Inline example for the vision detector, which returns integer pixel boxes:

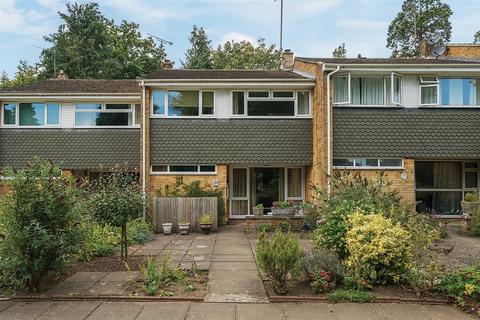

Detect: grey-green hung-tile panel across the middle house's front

[150,119,312,165]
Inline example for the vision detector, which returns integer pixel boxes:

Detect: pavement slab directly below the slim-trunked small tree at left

[85,302,144,320]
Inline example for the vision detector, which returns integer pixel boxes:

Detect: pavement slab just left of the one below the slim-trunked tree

[37,301,101,320]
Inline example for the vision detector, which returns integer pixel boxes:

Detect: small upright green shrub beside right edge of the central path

[257,230,303,294]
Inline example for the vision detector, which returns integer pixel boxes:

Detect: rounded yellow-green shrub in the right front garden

[346,212,412,284]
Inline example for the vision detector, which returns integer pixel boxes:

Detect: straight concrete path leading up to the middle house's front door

[205,224,267,302]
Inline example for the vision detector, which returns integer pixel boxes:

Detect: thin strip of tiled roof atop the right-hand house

[295,57,480,65]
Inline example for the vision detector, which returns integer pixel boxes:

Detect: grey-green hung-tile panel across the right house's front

[333,107,480,159]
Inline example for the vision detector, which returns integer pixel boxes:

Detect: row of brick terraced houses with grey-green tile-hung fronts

[0,46,480,219]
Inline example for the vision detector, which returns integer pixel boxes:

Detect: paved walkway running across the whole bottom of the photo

[0,301,474,320]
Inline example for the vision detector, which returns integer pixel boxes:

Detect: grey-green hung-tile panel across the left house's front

[0,129,140,169]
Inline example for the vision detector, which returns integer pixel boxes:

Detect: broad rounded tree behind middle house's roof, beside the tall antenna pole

[213,38,282,70]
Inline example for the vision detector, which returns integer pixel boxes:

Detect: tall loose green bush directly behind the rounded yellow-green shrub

[310,172,400,259]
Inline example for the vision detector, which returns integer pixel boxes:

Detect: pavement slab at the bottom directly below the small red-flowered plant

[282,303,341,320]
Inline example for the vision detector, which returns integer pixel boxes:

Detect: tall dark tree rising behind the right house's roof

[387,0,452,58]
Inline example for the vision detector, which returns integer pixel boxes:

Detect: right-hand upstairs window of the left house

[75,103,136,127]
